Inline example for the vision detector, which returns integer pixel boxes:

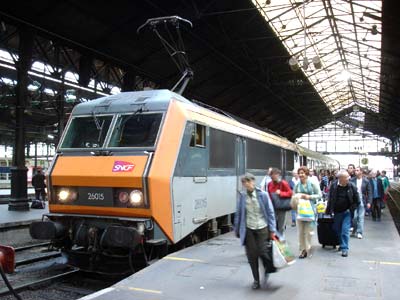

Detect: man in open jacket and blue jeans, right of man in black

[350,167,372,239]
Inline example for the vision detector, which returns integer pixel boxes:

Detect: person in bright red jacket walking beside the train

[268,168,292,239]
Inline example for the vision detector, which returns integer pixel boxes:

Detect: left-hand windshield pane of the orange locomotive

[61,116,113,148]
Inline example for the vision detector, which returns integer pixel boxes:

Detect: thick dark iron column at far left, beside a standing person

[8,28,34,210]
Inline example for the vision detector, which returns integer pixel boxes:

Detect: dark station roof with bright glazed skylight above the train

[0,0,400,140]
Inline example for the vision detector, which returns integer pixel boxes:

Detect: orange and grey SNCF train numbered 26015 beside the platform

[30,90,338,273]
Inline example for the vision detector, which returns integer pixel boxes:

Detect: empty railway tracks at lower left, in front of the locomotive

[0,242,122,300]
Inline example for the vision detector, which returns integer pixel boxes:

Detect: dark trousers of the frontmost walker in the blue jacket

[245,227,276,282]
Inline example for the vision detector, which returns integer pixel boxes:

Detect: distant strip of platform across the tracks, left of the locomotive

[0,202,49,229]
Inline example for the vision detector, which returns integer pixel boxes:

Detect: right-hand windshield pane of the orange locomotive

[108,113,162,147]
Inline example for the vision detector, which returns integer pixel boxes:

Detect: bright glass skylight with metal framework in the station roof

[252,0,382,113]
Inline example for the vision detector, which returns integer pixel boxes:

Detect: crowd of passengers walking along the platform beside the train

[235,164,390,289]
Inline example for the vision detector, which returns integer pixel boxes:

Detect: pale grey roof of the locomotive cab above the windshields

[72,90,192,115]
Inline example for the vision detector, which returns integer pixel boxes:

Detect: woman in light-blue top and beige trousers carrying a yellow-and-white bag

[293,166,322,258]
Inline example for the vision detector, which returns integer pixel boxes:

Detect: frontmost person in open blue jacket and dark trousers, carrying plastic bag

[235,174,276,289]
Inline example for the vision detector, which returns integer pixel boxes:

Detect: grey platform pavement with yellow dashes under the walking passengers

[82,210,400,300]
